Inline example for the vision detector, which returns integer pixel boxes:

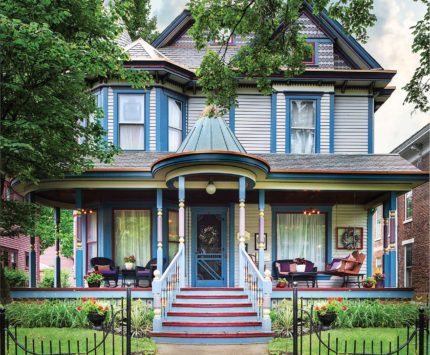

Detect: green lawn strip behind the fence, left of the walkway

[7,328,155,355]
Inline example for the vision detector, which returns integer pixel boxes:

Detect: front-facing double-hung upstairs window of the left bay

[118,94,145,150]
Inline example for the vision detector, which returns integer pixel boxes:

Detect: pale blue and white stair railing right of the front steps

[239,243,272,331]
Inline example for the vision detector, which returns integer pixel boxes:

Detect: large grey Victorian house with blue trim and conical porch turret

[10,3,428,340]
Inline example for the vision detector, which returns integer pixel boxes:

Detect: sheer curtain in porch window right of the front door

[277,213,326,270]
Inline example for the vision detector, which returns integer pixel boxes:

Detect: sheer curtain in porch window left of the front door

[114,210,151,266]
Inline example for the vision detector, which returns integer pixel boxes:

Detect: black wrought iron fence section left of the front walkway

[0,288,154,355]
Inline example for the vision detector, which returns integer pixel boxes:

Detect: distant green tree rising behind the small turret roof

[122,0,159,43]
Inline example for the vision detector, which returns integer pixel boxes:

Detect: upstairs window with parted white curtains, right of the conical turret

[291,100,316,154]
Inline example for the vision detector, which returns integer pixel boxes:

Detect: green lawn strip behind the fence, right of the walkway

[269,328,424,355]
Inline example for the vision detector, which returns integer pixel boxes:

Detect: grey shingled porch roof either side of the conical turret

[94,151,426,175]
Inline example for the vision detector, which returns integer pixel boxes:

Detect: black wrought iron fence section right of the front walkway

[275,285,430,355]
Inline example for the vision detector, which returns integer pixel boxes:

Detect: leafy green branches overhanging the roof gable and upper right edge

[189,0,430,111]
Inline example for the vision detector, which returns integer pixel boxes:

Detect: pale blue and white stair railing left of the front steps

[152,243,185,331]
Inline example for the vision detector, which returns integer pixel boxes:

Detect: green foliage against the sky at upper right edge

[403,0,430,112]
